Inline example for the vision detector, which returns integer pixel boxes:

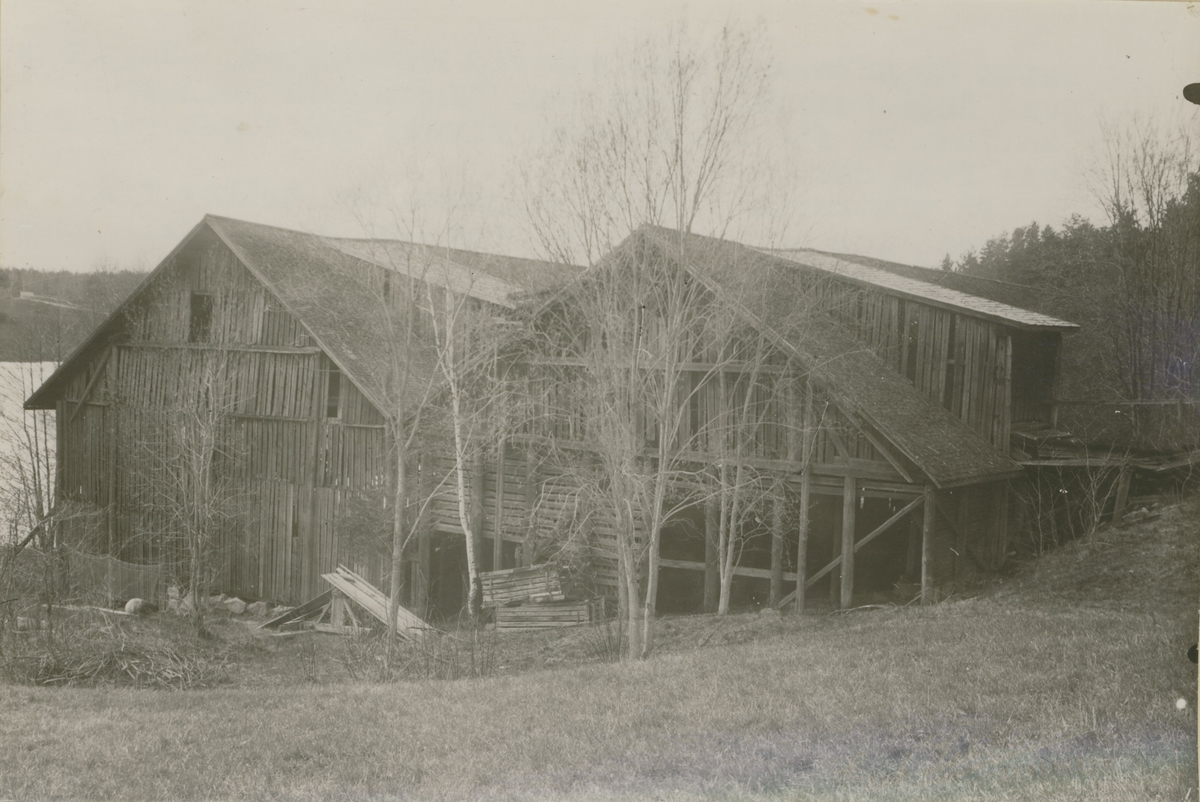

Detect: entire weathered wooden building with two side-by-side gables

[26,216,1074,614]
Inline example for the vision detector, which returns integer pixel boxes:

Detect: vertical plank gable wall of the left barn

[55,235,403,603]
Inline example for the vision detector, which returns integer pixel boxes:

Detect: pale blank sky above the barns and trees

[0,0,1200,270]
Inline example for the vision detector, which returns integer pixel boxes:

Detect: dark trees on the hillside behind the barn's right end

[942,163,1200,451]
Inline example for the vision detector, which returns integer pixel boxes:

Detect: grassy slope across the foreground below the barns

[0,499,1200,800]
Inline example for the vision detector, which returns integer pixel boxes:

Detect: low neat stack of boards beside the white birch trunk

[479,564,604,632]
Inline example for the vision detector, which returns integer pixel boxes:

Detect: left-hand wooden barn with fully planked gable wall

[25,216,569,612]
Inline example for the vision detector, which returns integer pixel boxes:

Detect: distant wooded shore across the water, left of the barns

[0,268,146,361]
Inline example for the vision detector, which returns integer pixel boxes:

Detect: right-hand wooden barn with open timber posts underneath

[506,227,1075,611]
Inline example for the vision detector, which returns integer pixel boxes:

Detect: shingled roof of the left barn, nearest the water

[25,215,572,409]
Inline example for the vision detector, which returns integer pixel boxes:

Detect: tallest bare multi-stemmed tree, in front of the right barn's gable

[522,26,791,657]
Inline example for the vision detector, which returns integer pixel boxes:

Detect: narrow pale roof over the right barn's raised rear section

[767,249,1079,331]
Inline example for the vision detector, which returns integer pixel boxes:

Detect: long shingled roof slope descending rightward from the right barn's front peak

[635,226,1021,487]
